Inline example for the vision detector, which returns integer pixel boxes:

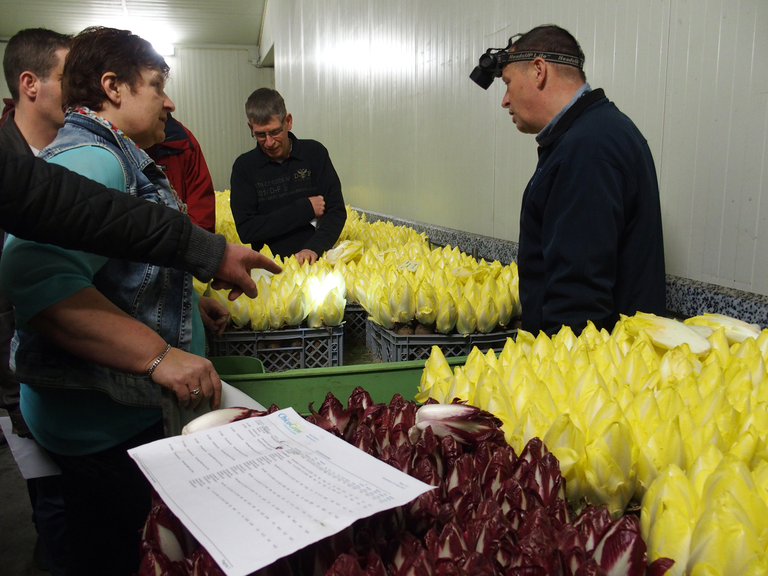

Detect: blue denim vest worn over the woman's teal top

[15,111,193,414]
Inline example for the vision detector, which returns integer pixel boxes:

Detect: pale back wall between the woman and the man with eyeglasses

[168,47,274,190]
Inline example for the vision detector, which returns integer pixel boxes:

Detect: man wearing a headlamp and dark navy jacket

[471,25,666,335]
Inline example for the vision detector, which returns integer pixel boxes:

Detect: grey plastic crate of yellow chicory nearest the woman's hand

[211,326,344,372]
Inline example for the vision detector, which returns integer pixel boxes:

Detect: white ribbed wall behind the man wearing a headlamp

[269,0,768,294]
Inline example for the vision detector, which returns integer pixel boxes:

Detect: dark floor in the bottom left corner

[0,410,50,576]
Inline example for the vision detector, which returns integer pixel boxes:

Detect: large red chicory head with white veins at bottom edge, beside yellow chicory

[592,516,647,576]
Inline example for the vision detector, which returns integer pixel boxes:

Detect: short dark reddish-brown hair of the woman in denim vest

[61,26,170,111]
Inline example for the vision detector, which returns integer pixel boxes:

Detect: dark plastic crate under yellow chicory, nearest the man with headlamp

[366,322,517,362]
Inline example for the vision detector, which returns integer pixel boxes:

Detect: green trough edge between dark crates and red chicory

[210,356,467,414]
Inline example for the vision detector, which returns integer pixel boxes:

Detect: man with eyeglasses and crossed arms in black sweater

[230,88,347,264]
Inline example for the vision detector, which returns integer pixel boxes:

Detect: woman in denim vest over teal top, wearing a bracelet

[0,28,234,576]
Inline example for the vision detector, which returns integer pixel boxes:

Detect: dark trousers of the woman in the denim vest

[45,422,163,576]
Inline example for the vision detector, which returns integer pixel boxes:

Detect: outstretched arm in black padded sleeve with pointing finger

[0,150,279,294]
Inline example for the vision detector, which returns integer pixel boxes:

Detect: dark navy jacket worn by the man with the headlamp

[518,90,666,335]
